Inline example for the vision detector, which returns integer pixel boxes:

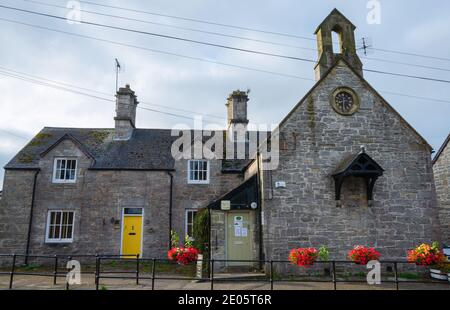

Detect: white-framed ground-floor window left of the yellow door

[45,210,74,242]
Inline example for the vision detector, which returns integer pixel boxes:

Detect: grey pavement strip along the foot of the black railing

[0,274,450,290]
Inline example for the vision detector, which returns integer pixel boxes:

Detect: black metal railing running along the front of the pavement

[0,254,450,290]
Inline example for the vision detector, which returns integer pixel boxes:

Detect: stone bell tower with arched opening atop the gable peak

[314,9,362,80]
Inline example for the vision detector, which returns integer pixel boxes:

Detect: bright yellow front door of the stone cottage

[122,215,142,258]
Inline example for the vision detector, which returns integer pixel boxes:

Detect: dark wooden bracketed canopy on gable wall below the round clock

[333,148,384,201]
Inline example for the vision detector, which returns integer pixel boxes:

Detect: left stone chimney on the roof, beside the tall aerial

[114,84,138,140]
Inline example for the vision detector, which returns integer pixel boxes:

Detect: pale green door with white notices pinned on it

[227,212,254,266]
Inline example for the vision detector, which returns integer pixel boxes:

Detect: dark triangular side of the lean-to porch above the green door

[207,175,259,210]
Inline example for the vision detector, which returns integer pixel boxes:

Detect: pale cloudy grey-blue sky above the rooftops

[0,0,450,188]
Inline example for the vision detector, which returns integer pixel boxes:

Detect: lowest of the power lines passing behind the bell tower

[0,18,450,103]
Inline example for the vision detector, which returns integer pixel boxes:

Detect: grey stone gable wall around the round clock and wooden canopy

[263,62,440,260]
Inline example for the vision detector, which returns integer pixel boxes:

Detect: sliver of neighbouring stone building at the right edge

[433,135,450,247]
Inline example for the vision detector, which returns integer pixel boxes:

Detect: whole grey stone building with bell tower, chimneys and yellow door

[0,10,441,265]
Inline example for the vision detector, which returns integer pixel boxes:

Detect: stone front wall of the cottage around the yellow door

[0,139,242,258]
